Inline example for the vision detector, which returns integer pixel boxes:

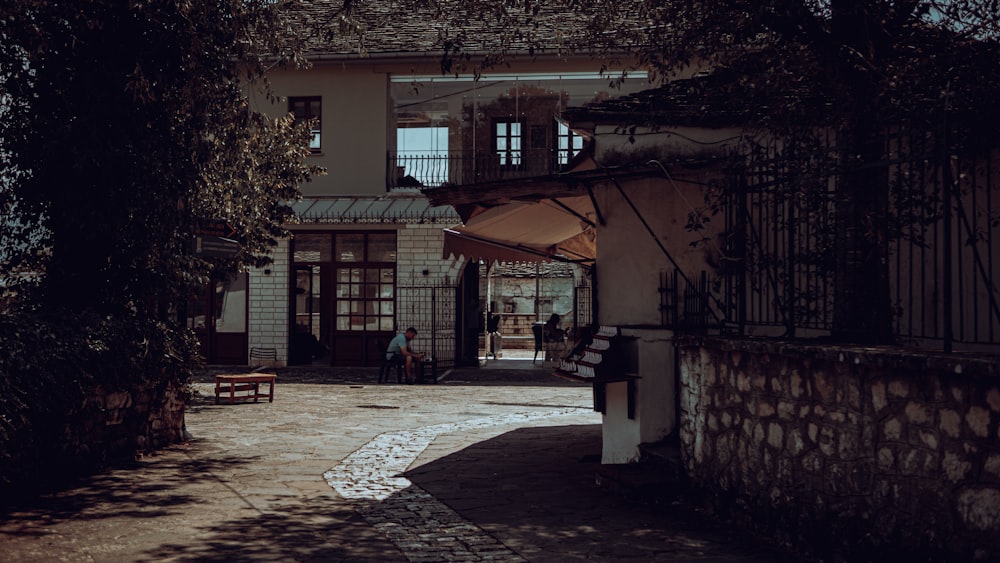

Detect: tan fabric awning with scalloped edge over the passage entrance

[444,196,597,264]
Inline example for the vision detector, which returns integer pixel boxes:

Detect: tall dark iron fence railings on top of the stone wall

[660,131,1000,351]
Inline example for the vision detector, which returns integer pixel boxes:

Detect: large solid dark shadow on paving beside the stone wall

[406,424,795,561]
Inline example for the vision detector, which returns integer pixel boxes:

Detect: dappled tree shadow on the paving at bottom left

[0,448,405,563]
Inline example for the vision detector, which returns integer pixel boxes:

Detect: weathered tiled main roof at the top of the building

[284,0,645,58]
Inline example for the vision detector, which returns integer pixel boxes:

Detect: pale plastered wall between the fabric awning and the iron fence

[597,131,731,463]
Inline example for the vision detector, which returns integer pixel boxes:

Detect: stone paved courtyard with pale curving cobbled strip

[0,362,786,562]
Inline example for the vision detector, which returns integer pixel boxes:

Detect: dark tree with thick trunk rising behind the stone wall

[608,0,1000,342]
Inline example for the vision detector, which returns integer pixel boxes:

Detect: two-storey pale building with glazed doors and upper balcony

[189,2,648,366]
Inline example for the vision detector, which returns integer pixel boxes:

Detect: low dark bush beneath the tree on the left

[0,311,199,496]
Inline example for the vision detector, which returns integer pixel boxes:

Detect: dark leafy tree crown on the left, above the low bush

[0,0,316,316]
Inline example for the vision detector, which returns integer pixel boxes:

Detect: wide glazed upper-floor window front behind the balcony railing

[386,72,655,188]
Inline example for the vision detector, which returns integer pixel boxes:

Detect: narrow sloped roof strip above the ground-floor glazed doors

[292,193,461,225]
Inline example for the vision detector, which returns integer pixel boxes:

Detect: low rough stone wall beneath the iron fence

[679,339,1000,560]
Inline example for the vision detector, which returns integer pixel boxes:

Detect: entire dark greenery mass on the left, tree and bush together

[0,0,318,494]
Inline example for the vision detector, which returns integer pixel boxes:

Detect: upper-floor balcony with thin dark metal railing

[385,148,568,190]
